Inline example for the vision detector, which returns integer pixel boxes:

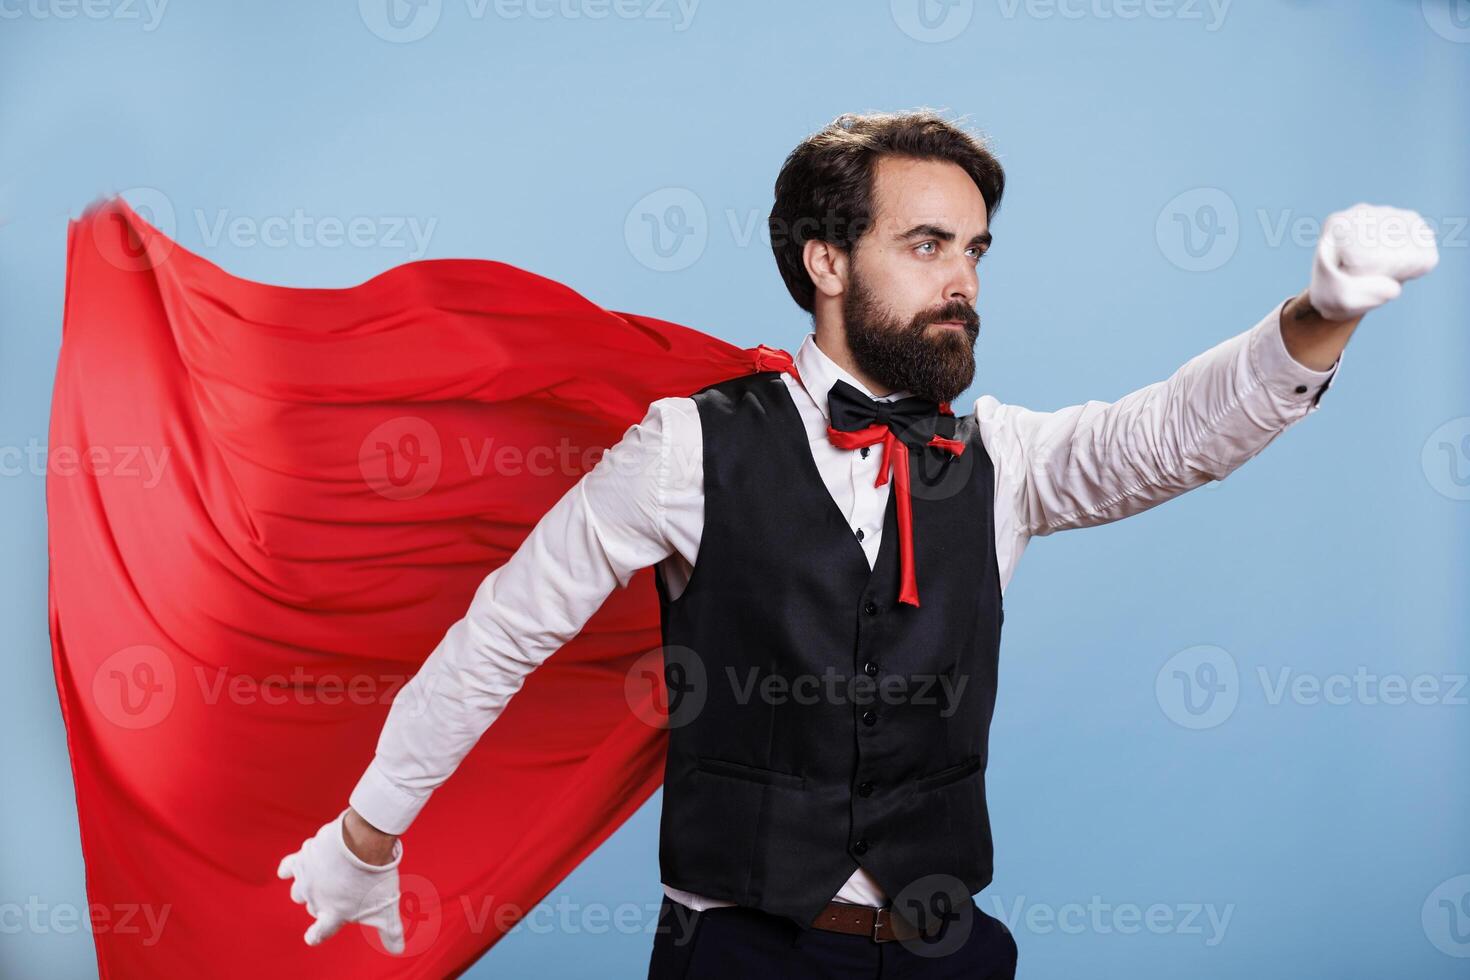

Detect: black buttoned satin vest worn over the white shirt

[656,370,1004,926]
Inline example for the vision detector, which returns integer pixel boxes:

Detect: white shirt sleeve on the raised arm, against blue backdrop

[975,300,1341,586]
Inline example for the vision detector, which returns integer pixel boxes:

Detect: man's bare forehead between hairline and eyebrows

[873,157,989,238]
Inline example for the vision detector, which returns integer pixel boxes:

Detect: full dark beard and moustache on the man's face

[844,265,980,403]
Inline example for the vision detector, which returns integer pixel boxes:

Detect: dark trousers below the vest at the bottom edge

[648,895,1017,980]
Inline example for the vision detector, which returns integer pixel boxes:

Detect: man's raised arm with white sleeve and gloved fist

[975,206,1438,583]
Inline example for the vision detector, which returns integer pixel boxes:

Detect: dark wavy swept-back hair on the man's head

[767,109,1005,313]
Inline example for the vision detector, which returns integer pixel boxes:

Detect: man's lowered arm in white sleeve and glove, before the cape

[276,398,682,952]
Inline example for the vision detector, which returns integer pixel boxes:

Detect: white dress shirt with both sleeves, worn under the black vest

[350,301,1341,908]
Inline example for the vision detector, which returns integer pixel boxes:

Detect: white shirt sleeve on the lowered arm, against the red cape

[348,398,679,835]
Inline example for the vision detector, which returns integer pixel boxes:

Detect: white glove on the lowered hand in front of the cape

[276,808,403,954]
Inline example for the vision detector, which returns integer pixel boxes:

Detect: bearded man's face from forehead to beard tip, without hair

[842,157,991,401]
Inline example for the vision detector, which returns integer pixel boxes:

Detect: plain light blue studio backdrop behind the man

[0,0,1470,980]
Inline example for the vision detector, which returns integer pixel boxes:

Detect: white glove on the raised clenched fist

[1307,204,1439,320]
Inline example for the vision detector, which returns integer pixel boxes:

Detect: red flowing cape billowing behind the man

[46,198,789,979]
